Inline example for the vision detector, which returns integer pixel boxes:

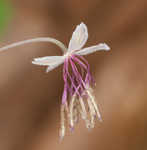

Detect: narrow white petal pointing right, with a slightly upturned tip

[75,43,110,55]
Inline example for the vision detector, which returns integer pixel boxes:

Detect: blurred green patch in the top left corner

[0,0,12,36]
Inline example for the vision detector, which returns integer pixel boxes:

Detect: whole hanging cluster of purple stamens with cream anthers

[59,55,101,138]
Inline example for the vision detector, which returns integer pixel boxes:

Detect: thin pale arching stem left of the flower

[0,37,67,53]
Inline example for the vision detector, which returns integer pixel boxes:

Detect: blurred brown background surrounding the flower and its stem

[0,0,147,150]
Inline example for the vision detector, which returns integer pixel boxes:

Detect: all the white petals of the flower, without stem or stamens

[32,23,110,72]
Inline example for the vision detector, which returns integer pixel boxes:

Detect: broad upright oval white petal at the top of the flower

[68,23,88,51]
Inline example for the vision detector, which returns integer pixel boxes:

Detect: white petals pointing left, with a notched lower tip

[32,56,64,72]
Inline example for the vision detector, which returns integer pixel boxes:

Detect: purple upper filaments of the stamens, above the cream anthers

[62,55,94,104]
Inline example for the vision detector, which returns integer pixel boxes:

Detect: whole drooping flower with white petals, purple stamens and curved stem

[0,23,110,138]
